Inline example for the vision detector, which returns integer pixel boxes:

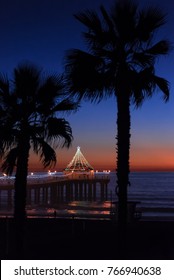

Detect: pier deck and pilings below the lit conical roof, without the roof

[0,174,109,207]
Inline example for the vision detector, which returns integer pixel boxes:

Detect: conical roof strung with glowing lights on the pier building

[65,147,94,172]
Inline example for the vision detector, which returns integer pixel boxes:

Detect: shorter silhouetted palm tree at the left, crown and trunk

[0,63,77,221]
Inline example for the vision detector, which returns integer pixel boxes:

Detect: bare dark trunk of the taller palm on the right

[117,89,130,234]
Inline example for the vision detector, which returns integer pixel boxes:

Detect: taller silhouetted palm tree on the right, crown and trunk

[65,0,171,228]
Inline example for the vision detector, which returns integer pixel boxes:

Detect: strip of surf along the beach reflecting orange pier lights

[0,203,174,221]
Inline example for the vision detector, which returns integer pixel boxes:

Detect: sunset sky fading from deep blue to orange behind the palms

[0,0,174,171]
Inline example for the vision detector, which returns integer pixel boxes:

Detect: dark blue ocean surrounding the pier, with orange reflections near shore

[0,172,174,220]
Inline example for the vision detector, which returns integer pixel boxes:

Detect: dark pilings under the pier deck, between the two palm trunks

[27,178,109,204]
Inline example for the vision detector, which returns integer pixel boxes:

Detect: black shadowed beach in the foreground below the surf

[0,218,174,260]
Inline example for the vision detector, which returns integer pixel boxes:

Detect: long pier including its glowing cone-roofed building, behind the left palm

[0,147,110,208]
